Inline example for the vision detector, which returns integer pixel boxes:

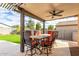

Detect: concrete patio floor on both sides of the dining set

[0,40,77,56]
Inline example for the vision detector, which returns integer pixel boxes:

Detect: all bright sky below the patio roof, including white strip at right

[0,7,77,27]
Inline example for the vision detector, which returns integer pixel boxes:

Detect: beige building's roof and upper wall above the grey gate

[56,20,78,30]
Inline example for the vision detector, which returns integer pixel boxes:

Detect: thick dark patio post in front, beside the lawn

[20,9,24,52]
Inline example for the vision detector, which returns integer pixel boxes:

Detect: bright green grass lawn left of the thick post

[0,34,20,43]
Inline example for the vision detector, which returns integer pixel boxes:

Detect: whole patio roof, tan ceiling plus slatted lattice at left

[0,3,79,21]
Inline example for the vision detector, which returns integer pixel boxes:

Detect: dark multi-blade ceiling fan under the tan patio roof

[47,3,64,18]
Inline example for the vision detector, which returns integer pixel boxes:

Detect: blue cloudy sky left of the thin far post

[0,7,40,26]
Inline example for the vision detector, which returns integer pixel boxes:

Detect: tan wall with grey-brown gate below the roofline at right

[56,26,78,41]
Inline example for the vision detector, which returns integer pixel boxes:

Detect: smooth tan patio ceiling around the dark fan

[20,3,79,20]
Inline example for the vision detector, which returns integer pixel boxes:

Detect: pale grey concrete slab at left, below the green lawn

[0,40,20,56]
